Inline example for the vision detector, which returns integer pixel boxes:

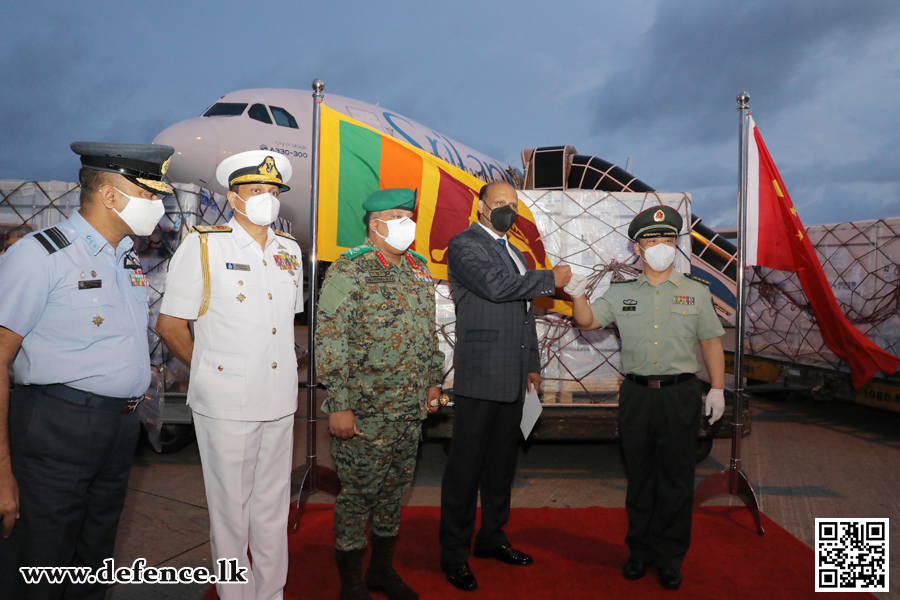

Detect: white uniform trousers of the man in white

[194,413,294,600]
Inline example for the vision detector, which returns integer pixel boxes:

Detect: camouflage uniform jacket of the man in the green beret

[316,246,444,421]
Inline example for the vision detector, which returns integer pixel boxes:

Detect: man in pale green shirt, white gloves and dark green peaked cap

[566,206,725,589]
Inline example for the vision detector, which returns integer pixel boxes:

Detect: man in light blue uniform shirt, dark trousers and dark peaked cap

[0,142,174,600]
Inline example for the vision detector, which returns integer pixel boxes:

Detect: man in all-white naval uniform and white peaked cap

[156,150,303,600]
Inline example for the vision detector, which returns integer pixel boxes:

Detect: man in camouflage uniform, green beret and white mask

[316,189,444,600]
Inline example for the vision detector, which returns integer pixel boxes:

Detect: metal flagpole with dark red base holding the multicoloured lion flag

[288,79,341,532]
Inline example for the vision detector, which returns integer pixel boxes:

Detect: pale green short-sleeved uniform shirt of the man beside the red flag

[591,271,725,376]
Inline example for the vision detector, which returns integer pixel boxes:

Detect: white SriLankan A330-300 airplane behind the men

[153,88,522,248]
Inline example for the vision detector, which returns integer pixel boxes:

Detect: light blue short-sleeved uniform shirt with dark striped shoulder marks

[0,212,150,398]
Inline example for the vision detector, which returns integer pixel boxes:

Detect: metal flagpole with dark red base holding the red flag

[694,92,765,535]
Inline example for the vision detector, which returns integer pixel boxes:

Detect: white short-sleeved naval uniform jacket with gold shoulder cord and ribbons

[160,219,303,421]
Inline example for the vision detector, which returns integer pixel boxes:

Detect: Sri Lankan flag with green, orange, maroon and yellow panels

[317,105,551,279]
